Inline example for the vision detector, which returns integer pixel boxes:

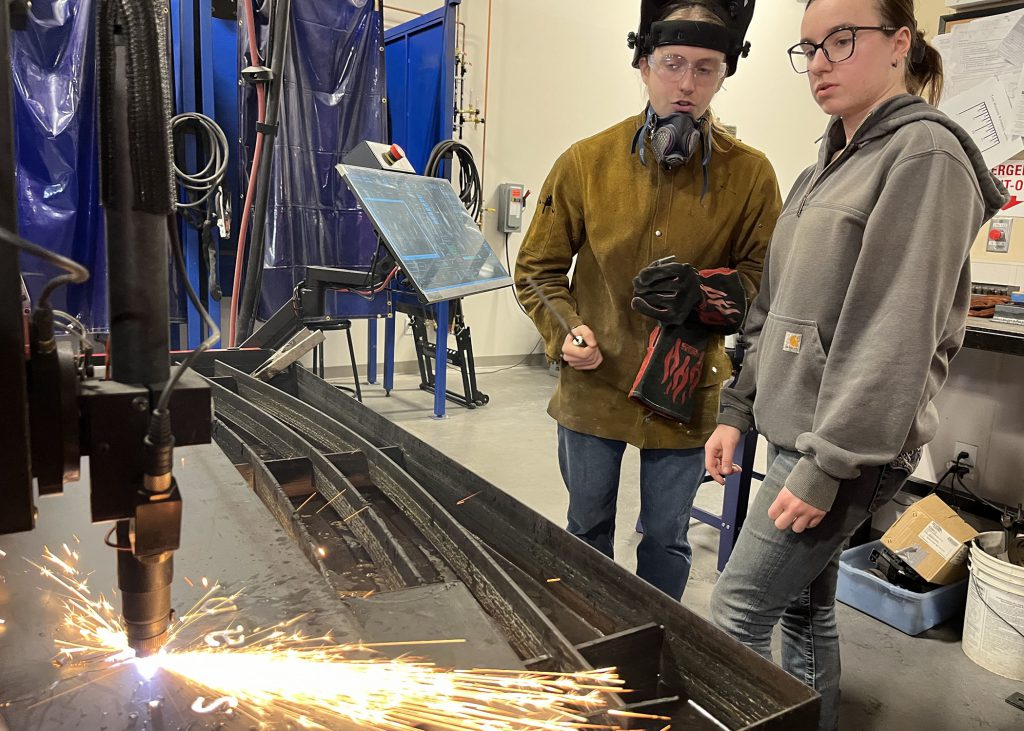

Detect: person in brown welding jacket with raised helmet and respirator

[515,1,781,599]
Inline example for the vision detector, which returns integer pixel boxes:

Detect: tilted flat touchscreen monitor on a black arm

[338,165,512,303]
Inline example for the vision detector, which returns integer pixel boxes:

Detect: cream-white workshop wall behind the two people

[321,0,1024,503]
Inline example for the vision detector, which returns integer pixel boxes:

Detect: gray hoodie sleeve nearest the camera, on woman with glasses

[786,148,984,510]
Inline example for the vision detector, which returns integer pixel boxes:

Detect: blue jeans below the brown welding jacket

[558,426,705,600]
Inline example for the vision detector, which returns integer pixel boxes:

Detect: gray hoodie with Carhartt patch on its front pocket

[719,94,1008,510]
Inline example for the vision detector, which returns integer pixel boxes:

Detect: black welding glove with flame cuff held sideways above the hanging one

[630,259,746,335]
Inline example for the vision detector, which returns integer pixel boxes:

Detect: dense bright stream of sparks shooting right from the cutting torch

[162,637,617,731]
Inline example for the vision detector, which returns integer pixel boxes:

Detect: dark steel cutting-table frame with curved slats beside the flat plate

[203,363,819,731]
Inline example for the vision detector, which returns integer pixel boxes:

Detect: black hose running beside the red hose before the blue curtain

[237,0,292,342]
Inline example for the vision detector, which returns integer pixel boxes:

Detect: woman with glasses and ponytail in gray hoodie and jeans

[707,0,1007,731]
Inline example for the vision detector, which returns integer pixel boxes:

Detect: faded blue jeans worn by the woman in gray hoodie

[711,447,908,731]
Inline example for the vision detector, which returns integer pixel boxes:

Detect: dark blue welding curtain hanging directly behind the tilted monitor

[239,0,387,319]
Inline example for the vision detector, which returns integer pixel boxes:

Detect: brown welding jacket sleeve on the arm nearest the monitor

[515,147,586,360]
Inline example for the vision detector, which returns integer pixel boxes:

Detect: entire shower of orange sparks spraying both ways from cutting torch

[30,546,634,731]
